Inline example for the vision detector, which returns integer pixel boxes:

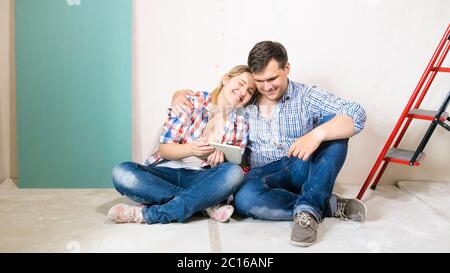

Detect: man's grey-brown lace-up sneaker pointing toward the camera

[291,211,319,246]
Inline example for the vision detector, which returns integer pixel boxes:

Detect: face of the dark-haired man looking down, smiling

[253,59,290,102]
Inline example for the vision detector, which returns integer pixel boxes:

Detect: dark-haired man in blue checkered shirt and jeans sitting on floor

[171,41,366,246]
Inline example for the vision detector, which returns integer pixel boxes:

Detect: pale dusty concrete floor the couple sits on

[0,177,450,252]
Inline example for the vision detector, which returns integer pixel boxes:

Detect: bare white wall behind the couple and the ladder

[133,0,450,184]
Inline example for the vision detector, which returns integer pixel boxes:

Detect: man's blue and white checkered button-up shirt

[245,78,366,167]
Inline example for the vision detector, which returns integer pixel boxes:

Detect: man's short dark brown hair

[247,41,288,73]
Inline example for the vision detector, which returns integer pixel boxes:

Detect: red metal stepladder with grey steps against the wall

[356,24,450,200]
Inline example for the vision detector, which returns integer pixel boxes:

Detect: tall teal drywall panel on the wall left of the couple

[15,0,132,188]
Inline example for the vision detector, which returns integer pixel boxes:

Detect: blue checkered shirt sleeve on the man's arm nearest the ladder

[305,86,367,135]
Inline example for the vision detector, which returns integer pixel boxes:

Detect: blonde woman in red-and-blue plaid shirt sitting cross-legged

[108,65,256,224]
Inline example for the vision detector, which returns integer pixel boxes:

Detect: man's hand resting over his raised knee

[288,128,325,161]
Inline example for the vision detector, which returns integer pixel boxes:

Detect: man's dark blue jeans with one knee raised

[234,116,348,221]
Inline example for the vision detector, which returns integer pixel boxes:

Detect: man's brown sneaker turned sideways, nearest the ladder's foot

[333,193,367,221]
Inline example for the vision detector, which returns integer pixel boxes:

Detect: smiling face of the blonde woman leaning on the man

[221,72,256,107]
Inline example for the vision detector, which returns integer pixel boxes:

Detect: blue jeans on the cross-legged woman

[112,162,244,224]
